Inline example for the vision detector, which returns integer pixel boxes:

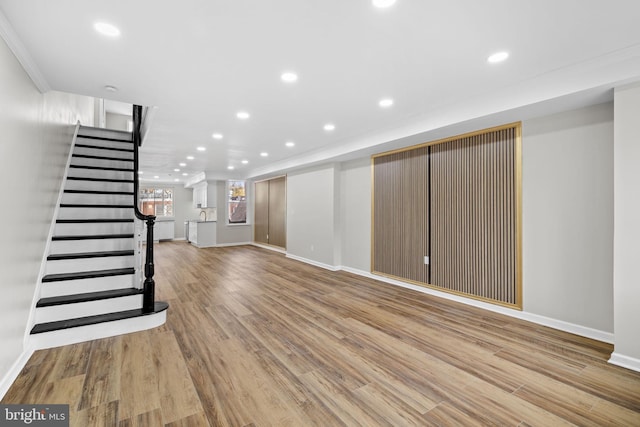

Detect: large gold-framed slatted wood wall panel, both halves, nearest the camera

[372,123,522,308]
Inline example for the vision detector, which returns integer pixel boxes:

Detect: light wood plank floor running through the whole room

[2,242,640,426]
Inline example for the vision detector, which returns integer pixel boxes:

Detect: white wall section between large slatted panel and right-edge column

[522,103,613,332]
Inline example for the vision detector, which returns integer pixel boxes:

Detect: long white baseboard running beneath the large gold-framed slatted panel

[342,267,614,344]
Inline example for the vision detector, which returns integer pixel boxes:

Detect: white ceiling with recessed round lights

[0,0,640,184]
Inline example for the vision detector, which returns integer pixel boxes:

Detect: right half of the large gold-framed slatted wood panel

[431,128,518,305]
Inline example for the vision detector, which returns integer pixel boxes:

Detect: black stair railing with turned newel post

[133,105,156,313]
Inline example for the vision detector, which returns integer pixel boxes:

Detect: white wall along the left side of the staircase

[0,39,94,389]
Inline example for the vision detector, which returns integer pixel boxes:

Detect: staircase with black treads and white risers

[31,127,168,348]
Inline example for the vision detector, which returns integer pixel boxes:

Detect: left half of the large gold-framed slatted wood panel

[372,147,429,283]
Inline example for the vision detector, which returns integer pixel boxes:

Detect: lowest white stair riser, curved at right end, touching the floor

[29,310,167,349]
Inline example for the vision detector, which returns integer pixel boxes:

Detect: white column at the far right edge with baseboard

[609,82,640,371]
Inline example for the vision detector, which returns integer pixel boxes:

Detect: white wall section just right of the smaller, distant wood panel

[287,164,340,267]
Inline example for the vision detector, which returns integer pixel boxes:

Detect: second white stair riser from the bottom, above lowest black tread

[35,295,142,323]
